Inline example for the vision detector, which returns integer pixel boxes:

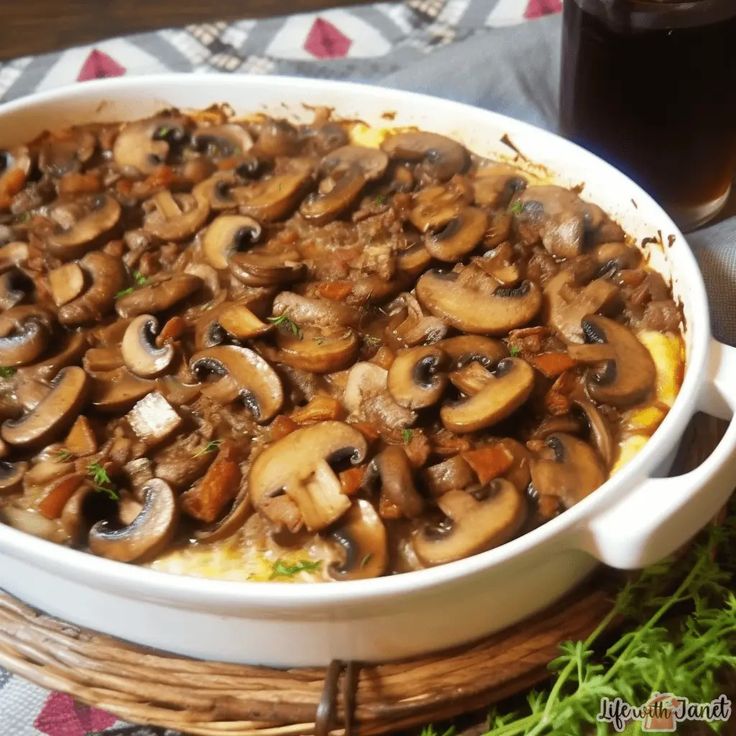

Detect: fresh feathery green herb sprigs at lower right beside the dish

[423,509,736,736]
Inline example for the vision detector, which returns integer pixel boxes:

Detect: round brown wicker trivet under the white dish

[0,579,610,736]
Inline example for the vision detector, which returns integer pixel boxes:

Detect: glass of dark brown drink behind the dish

[560,0,736,229]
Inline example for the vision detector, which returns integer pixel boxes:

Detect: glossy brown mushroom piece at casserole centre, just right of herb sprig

[276,329,360,373]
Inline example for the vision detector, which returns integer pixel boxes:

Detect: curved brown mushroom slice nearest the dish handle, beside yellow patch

[582,315,657,408]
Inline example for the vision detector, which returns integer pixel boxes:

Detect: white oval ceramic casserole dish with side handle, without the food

[0,75,736,667]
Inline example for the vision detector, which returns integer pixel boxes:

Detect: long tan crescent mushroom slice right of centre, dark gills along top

[416,270,542,335]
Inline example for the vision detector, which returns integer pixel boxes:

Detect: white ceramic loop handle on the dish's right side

[580,340,736,570]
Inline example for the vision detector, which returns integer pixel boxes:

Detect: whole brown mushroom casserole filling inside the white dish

[0,108,684,581]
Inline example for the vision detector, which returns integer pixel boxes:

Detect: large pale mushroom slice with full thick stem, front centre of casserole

[248,421,367,531]
